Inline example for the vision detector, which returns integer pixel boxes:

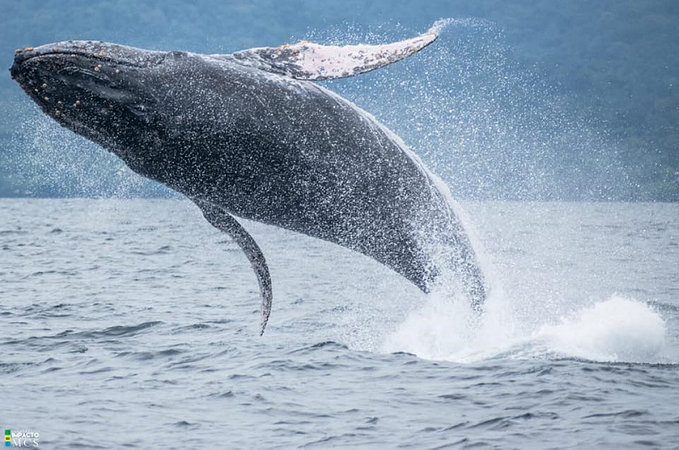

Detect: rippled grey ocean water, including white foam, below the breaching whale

[0,199,679,449]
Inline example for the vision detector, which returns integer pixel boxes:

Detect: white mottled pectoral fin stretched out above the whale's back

[228,31,438,80]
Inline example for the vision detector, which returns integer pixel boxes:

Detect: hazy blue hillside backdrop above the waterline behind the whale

[0,0,679,201]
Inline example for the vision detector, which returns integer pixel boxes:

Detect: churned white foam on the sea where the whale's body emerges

[382,289,666,363]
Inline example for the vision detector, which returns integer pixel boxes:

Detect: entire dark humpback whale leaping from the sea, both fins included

[10,26,487,333]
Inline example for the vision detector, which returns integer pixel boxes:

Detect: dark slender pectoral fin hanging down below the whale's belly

[194,200,273,336]
